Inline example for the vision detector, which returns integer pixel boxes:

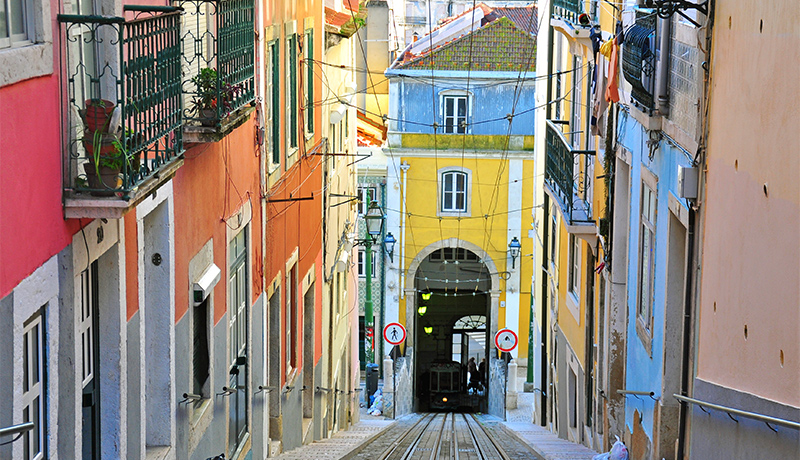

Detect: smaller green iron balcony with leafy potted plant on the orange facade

[179,0,255,144]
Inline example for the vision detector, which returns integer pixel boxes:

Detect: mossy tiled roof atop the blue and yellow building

[398,17,536,71]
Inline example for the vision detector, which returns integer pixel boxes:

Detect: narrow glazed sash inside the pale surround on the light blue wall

[637,182,656,330]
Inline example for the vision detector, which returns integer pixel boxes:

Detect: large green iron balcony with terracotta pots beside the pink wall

[58,6,183,218]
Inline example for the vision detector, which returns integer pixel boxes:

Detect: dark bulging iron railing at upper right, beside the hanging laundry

[622,10,656,110]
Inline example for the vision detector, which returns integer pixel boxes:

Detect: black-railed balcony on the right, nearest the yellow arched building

[544,120,595,233]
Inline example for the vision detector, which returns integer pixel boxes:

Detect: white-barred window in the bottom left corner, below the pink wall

[22,314,45,460]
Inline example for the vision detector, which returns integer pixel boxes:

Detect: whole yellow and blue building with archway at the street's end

[384,7,536,414]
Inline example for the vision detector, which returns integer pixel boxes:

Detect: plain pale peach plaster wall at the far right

[697,0,800,408]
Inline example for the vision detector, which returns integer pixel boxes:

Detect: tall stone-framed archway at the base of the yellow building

[405,238,499,412]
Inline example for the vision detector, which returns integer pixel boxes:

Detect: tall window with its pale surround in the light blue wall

[636,168,658,341]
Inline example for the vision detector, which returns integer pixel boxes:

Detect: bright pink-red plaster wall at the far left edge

[0,52,79,296]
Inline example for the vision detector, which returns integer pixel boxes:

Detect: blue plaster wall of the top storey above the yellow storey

[387,75,536,135]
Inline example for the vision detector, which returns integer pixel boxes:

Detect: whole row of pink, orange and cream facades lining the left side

[0,0,358,459]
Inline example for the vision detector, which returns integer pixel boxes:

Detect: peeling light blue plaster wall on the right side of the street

[618,109,691,440]
